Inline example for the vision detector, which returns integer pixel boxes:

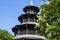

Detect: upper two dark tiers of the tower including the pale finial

[18,1,39,23]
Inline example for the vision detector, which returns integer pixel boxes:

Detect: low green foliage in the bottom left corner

[0,29,13,40]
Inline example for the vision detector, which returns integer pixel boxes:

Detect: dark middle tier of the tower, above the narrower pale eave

[18,14,38,23]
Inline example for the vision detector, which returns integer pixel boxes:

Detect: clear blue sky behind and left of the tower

[0,0,47,33]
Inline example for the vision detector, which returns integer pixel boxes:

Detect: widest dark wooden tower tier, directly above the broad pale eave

[12,24,39,36]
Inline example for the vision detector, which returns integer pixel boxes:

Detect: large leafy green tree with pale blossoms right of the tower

[36,0,60,40]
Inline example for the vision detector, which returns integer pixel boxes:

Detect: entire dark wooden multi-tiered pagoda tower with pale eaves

[12,1,46,40]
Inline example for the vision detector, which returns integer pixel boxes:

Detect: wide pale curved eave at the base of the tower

[13,35,46,40]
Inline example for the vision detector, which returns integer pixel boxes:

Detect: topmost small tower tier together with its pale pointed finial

[23,1,39,14]
